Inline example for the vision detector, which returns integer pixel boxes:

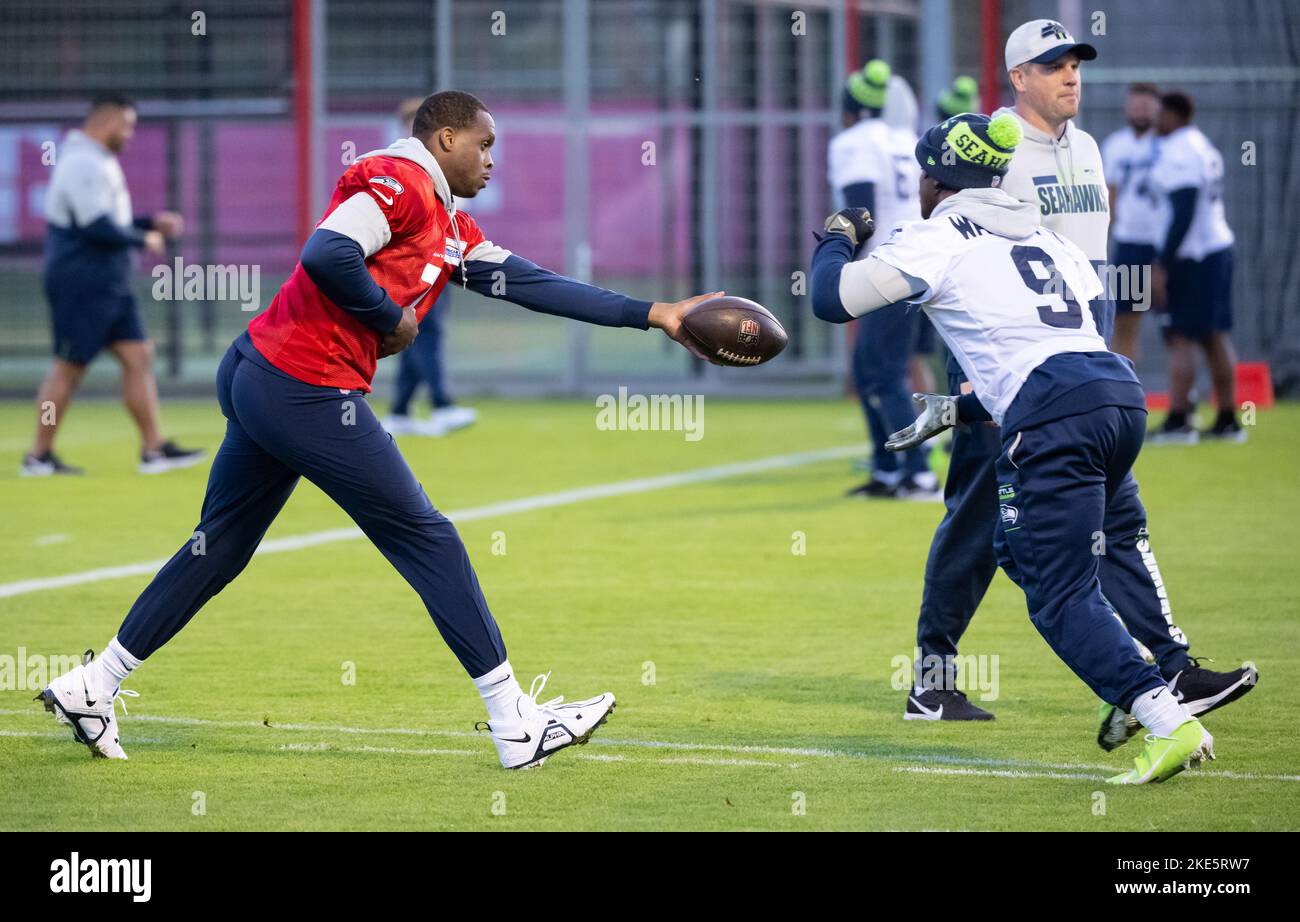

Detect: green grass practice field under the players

[0,401,1300,830]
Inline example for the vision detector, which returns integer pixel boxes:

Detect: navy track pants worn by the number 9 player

[995,407,1165,710]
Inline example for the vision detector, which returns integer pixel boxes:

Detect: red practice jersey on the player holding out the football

[248,151,484,391]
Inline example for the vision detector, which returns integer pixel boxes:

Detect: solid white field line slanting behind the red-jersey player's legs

[0,443,866,598]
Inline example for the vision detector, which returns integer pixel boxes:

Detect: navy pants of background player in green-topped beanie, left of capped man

[853,302,930,476]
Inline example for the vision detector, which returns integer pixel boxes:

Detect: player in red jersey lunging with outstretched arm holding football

[38,91,722,769]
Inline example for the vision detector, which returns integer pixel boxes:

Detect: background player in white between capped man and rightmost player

[1101,83,1167,362]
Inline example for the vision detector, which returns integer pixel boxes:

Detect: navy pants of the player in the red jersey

[117,337,506,678]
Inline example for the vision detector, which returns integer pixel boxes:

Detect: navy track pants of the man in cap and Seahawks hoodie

[917,364,1188,688]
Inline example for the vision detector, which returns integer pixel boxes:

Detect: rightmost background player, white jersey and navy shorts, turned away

[1152,92,1245,442]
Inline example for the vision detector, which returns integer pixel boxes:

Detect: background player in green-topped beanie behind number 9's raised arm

[827,60,939,499]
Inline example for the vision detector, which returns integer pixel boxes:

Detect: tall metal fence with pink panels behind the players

[0,0,1300,395]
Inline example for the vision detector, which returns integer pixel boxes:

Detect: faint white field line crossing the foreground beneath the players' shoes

[0,709,1300,782]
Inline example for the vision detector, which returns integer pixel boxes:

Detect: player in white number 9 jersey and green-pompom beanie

[811,114,1214,784]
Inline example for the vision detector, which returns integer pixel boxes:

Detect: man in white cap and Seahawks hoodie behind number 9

[893,20,1257,750]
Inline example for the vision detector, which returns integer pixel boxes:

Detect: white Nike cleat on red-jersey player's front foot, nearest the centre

[475,672,614,769]
